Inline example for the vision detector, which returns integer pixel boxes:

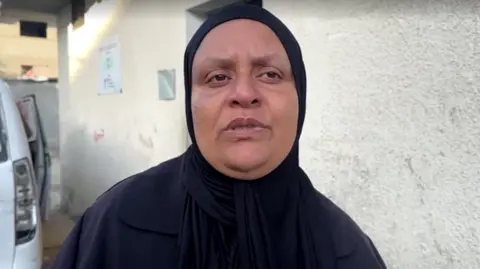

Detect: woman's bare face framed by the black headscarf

[191,19,298,180]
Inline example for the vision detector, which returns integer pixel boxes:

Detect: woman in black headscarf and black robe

[49,6,386,269]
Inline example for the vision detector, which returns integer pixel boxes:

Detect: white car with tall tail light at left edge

[0,80,43,269]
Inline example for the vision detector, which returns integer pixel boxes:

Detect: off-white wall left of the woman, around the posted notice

[59,0,202,215]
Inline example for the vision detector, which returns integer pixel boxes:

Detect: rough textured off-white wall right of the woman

[266,0,480,269]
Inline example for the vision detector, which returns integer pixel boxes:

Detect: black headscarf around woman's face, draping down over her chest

[178,5,333,269]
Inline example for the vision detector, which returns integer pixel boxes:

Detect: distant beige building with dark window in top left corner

[0,10,58,78]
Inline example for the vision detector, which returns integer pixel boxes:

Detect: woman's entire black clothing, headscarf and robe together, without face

[49,6,386,269]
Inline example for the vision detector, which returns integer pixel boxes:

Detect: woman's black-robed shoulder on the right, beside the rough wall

[312,192,386,268]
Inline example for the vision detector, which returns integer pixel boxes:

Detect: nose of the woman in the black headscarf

[228,77,261,108]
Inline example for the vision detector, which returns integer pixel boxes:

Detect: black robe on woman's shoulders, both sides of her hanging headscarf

[52,155,387,269]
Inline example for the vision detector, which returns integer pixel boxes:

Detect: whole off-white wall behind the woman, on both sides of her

[59,0,480,269]
